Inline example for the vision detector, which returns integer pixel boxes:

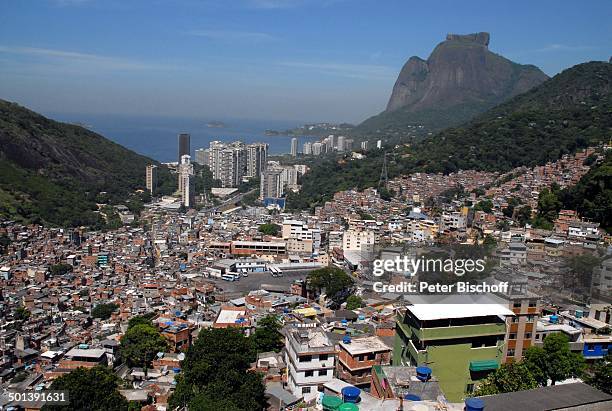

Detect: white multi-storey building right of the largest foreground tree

[285,328,336,401]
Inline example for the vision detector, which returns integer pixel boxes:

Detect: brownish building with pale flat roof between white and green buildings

[336,336,391,386]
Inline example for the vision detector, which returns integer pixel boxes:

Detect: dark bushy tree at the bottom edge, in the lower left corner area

[42,366,128,411]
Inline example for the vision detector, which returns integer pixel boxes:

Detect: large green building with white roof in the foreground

[393,304,514,401]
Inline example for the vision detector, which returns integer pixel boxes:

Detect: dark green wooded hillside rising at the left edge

[0,100,165,226]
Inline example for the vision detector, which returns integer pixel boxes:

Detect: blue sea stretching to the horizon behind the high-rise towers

[50,114,319,162]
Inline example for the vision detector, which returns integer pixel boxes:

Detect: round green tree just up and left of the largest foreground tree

[120,323,168,368]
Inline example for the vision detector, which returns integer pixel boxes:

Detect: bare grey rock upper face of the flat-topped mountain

[387,33,548,111]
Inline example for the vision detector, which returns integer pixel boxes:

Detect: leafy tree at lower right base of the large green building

[474,363,538,397]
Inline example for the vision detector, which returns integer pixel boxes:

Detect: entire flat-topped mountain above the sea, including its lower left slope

[356,33,548,135]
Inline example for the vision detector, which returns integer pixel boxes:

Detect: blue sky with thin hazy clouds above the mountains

[0,0,612,122]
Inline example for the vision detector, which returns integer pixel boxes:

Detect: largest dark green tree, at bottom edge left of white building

[169,328,267,411]
